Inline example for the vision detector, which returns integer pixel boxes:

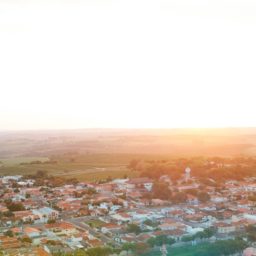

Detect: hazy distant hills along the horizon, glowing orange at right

[0,128,256,159]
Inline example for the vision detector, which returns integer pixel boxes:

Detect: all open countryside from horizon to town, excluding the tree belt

[0,128,256,181]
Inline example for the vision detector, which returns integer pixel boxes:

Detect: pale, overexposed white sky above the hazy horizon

[0,0,256,130]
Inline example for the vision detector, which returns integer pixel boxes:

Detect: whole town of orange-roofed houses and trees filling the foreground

[0,157,256,256]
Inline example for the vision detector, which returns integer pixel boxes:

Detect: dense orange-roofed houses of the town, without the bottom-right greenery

[0,169,256,255]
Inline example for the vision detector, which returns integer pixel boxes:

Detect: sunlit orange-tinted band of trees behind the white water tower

[128,157,256,182]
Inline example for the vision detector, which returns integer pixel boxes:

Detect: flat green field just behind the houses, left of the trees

[0,154,138,181]
